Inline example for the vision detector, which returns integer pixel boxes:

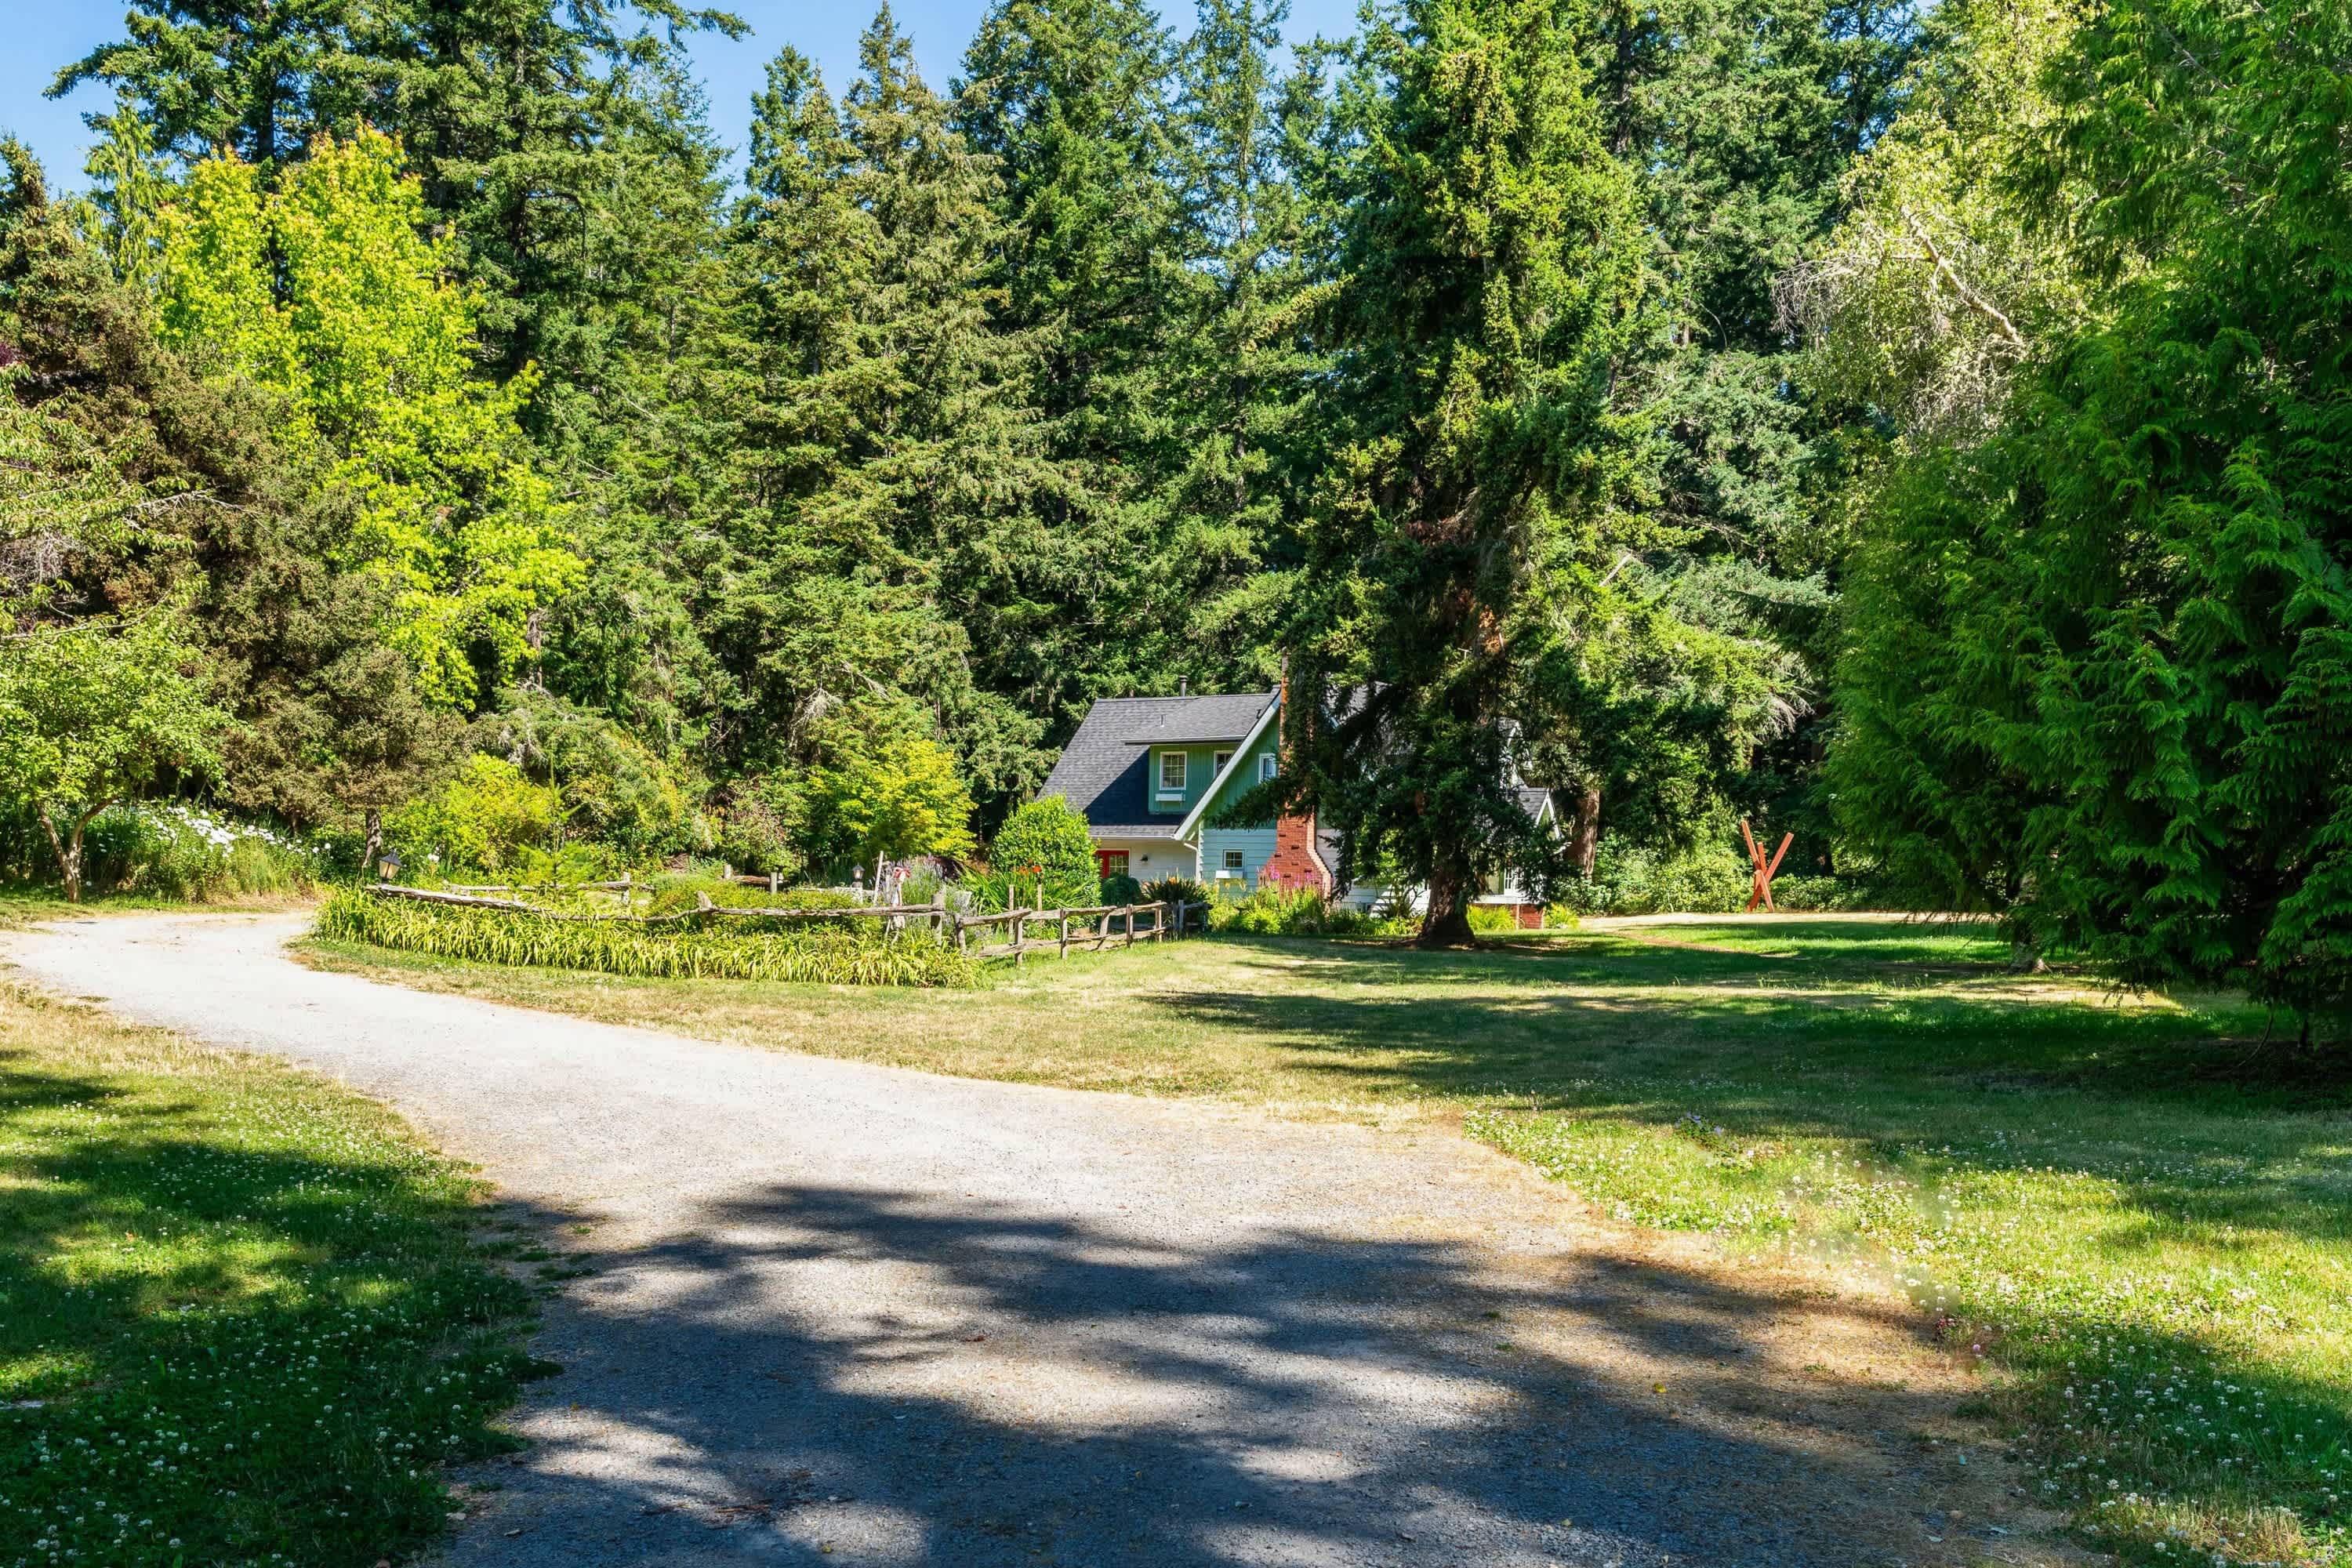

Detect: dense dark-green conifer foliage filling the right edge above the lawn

[1837,0,2352,1011]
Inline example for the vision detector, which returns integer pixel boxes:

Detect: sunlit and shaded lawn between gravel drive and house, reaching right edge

[315,916,2352,1563]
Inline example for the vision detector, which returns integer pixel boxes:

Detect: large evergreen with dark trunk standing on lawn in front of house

[1282,0,1651,942]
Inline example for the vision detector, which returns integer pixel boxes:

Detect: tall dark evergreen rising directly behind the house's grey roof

[955,0,1192,710]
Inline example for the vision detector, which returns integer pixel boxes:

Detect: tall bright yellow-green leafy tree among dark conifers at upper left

[162,129,581,708]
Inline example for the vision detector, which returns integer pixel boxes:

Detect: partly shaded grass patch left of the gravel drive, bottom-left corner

[0,985,534,1568]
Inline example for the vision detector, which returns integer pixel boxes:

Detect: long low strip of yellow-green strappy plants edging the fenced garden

[318,888,974,985]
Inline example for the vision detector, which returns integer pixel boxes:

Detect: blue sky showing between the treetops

[0,0,1355,188]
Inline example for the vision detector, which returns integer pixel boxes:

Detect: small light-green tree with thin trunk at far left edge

[0,609,228,902]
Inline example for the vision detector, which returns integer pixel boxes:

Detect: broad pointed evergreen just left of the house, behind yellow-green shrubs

[703,21,1073,794]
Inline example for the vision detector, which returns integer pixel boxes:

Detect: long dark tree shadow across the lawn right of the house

[1145,926,2352,1243]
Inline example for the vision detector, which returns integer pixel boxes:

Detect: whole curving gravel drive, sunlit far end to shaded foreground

[7,916,2042,1568]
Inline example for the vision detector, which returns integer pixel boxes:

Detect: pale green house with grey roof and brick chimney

[1037,689,1557,926]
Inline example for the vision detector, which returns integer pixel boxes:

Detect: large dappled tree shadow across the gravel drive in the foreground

[433,1187,1992,1568]
